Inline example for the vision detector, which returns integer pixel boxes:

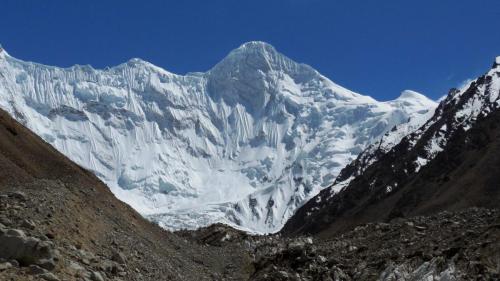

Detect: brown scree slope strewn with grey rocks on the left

[0,107,252,281]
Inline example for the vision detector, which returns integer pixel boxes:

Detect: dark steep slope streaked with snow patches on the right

[283,58,500,237]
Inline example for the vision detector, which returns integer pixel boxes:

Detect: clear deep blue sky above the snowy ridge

[0,0,500,100]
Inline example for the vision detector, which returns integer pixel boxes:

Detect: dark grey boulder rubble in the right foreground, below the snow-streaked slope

[252,208,500,281]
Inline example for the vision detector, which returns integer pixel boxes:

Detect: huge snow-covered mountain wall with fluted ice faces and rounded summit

[0,42,436,230]
